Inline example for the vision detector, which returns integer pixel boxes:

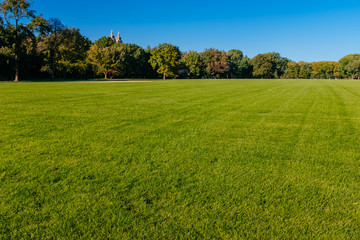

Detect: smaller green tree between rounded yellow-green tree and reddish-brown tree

[180,51,203,78]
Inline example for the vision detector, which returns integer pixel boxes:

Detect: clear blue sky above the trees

[33,0,360,61]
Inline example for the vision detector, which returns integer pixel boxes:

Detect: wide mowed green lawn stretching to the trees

[0,80,360,239]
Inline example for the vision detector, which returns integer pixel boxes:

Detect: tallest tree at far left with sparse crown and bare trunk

[0,0,36,82]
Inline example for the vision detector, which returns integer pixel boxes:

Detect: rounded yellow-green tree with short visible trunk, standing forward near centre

[149,43,181,79]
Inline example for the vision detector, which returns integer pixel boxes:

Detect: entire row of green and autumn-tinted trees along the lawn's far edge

[0,0,360,81]
